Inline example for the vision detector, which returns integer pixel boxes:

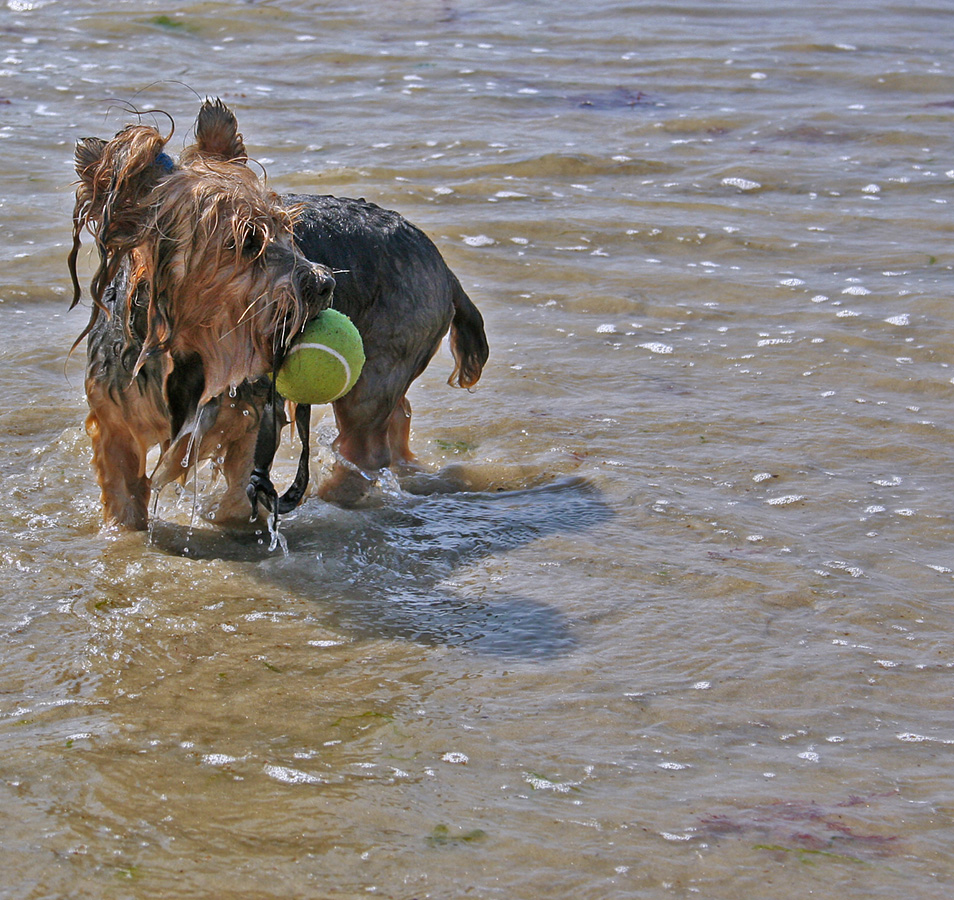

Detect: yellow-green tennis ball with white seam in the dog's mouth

[275,309,364,404]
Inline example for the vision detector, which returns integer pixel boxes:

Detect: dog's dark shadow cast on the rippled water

[152,478,613,659]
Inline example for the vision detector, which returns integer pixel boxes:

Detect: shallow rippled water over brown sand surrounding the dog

[0,0,954,900]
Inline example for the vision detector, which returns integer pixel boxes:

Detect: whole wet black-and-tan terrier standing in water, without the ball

[69,100,488,529]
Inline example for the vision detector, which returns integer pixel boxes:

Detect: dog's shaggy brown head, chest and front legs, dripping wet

[69,102,334,528]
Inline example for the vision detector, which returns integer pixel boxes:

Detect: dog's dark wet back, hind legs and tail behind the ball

[283,194,489,503]
